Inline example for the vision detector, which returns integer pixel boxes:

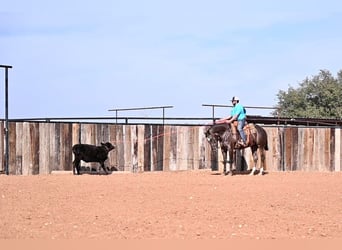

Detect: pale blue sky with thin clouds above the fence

[0,0,342,118]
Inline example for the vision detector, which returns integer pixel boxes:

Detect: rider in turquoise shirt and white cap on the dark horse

[216,96,248,147]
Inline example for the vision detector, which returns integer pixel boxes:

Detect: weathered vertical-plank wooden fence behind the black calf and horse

[0,122,342,175]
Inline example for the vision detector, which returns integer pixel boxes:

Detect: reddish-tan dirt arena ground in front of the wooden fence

[0,171,342,239]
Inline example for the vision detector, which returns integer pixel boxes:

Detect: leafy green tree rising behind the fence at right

[272,70,342,119]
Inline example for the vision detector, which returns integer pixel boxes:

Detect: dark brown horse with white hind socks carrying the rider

[205,123,268,175]
